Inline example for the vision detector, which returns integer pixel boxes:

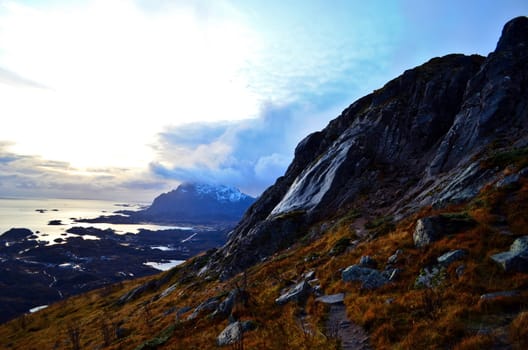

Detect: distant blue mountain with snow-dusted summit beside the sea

[136,183,255,223]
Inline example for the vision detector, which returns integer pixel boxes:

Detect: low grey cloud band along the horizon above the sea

[0,142,171,201]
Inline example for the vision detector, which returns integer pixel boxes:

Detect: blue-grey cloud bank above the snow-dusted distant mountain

[150,103,336,195]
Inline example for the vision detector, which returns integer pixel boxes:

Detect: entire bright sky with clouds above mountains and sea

[0,0,528,202]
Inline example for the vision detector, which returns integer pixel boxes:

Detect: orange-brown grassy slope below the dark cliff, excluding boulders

[0,171,528,350]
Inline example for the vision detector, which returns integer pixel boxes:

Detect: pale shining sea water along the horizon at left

[0,198,190,242]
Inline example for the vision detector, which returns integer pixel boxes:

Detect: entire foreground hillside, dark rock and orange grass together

[0,17,528,349]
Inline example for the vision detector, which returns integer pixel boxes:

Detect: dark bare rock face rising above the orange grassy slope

[208,17,528,278]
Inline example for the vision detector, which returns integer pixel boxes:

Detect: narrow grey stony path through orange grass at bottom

[326,303,371,350]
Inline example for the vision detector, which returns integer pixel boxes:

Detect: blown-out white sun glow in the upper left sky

[0,0,259,167]
